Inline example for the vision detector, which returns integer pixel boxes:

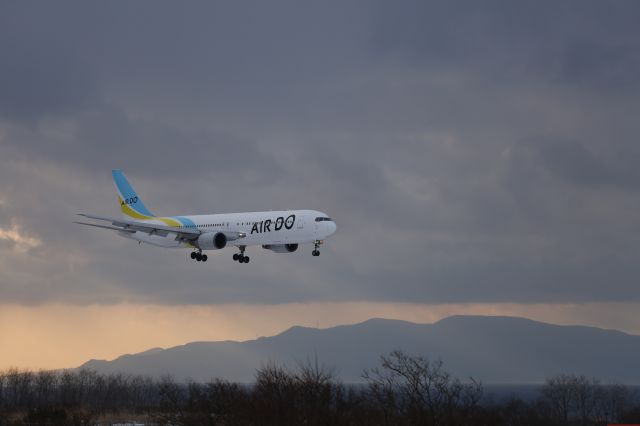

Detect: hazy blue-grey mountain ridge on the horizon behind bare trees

[81,316,640,384]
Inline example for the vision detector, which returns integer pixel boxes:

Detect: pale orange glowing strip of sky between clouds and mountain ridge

[0,302,640,369]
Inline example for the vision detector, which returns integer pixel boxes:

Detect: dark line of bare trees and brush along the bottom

[0,351,640,426]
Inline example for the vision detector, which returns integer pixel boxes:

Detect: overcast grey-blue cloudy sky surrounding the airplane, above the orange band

[0,0,640,368]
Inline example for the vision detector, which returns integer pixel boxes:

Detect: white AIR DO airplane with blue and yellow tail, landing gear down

[74,169,336,263]
